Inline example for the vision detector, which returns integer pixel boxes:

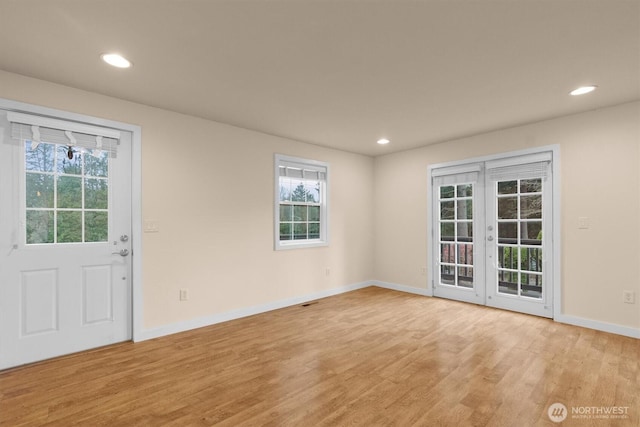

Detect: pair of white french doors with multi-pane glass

[431,152,553,317]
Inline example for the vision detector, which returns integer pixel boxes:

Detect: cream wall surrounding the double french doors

[374,102,640,330]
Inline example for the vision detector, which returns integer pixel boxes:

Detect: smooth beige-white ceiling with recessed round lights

[0,0,640,156]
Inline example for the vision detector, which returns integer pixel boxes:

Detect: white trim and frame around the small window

[273,154,330,251]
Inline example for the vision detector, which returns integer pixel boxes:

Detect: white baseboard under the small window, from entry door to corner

[133,281,372,342]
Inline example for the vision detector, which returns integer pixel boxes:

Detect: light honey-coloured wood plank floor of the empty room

[0,288,640,427]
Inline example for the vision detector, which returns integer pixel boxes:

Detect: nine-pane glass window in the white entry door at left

[24,141,109,245]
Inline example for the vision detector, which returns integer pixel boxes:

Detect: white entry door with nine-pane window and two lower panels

[0,110,131,369]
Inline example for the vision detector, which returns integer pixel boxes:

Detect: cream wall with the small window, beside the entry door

[0,71,373,329]
